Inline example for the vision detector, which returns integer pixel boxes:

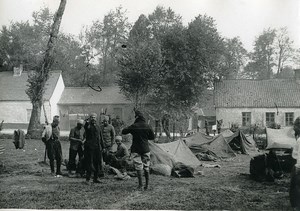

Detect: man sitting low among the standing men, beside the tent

[109,136,129,173]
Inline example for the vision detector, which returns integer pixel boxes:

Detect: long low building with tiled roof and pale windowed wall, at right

[214,69,300,128]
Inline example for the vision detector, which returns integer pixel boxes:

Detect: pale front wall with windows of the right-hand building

[216,108,300,128]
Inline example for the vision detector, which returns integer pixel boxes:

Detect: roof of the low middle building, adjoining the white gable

[58,87,132,105]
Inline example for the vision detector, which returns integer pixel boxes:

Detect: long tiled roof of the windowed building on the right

[214,79,300,108]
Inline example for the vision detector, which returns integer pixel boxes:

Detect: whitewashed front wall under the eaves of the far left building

[0,101,50,129]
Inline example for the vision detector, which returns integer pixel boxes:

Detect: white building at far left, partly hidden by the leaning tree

[0,68,65,129]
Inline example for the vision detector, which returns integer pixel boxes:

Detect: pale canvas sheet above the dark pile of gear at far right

[266,127,296,149]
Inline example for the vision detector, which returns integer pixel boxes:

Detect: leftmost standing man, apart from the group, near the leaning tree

[42,115,62,177]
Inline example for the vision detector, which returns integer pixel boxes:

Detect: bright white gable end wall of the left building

[47,74,65,122]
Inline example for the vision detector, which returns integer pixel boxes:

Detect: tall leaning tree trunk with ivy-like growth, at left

[26,0,67,137]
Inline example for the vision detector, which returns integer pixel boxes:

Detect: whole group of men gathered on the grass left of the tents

[42,110,154,189]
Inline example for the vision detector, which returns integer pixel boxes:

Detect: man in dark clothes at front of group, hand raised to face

[84,113,103,183]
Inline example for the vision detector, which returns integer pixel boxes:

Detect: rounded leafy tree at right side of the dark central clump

[187,15,224,82]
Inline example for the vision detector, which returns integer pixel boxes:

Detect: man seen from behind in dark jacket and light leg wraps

[122,110,155,190]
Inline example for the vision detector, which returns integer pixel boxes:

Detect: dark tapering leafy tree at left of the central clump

[118,15,162,107]
